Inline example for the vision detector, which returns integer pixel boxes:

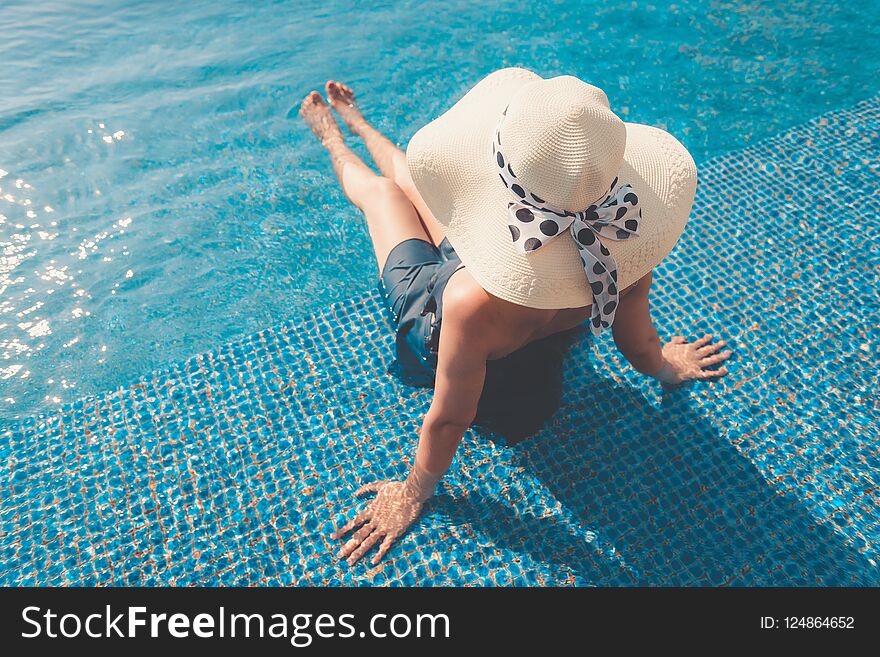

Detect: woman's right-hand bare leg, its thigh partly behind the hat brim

[326,80,443,245]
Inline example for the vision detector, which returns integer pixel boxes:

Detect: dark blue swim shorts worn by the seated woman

[378,237,464,388]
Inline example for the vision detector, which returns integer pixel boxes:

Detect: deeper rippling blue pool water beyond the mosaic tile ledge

[0,0,880,422]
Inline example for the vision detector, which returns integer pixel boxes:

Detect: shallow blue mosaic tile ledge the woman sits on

[0,97,880,585]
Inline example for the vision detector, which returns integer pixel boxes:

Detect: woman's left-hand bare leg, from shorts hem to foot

[300,91,431,274]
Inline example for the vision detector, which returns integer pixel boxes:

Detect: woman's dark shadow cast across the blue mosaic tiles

[458,356,877,586]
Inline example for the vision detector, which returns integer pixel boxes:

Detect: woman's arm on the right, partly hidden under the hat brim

[611,272,731,384]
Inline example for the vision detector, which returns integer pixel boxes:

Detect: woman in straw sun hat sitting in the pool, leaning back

[301,68,730,564]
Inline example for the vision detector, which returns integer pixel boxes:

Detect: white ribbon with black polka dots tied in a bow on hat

[492,116,642,335]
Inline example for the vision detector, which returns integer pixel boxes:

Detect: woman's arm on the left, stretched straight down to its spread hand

[332,290,489,564]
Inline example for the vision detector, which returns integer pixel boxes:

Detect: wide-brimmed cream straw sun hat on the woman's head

[406,68,697,326]
